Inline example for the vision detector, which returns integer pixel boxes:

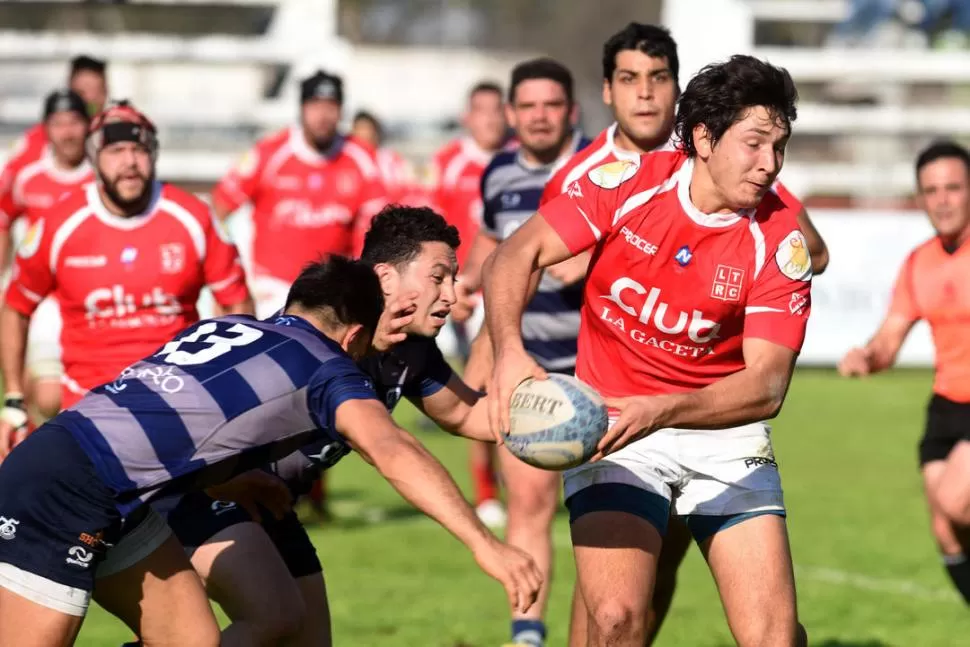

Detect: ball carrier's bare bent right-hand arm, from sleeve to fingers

[592,338,796,460]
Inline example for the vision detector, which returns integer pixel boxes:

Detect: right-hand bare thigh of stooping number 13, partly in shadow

[94,535,219,647]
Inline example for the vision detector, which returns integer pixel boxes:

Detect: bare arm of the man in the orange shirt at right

[838,254,921,377]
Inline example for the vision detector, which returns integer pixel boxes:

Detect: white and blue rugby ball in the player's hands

[505,373,608,471]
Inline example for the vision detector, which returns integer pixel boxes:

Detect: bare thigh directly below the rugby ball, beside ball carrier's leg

[498,447,561,525]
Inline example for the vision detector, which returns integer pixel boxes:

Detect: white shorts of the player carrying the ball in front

[563,420,785,516]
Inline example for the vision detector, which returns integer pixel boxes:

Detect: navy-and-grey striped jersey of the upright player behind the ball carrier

[482,133,590,373]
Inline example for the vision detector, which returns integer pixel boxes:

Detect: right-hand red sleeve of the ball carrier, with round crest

[744,229,812,353]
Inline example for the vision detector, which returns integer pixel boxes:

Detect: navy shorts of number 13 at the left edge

[0,424,123,591]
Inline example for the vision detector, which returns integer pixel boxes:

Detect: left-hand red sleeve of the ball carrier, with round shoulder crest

[539,161,650,254]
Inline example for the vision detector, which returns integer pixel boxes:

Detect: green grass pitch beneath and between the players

[73,370,970,647]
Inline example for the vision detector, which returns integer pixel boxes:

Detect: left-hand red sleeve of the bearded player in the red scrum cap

[6,216,55,317]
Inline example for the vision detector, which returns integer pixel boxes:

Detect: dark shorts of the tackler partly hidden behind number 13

[162,492,323,577]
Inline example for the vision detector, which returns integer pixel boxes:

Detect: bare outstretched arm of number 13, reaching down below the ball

[336,399,542,612]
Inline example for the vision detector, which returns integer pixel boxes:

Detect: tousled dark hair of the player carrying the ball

[675,55,798,157]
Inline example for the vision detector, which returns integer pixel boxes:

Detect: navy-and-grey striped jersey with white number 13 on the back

[52,316,377,514]
